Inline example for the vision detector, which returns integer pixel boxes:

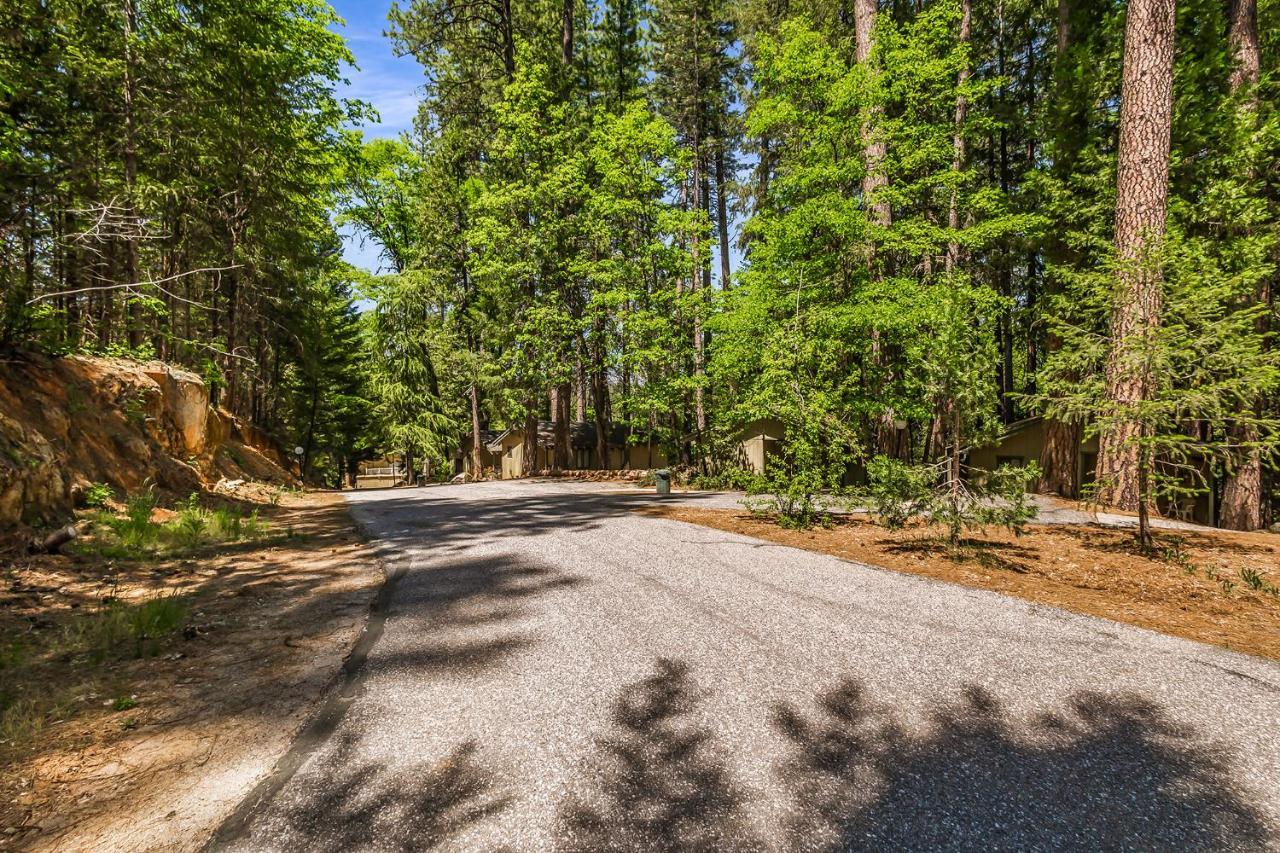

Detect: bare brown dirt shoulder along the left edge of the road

[0,494,383,850]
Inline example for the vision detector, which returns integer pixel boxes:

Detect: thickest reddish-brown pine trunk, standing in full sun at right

[1098,0,1175,512]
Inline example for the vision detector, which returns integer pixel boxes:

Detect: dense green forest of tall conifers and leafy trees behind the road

[0,0,1280,529]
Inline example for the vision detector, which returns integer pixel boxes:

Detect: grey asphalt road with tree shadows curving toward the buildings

[214,482,1280,850]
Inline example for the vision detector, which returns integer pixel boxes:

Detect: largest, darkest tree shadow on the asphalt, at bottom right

[774,680,1268,850]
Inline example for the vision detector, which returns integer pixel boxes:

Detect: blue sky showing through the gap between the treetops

[330,0,422,273]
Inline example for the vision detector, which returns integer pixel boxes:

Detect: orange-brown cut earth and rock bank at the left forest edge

[0,355,292,528]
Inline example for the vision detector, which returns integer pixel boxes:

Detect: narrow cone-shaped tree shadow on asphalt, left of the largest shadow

[561,660,762,853]
